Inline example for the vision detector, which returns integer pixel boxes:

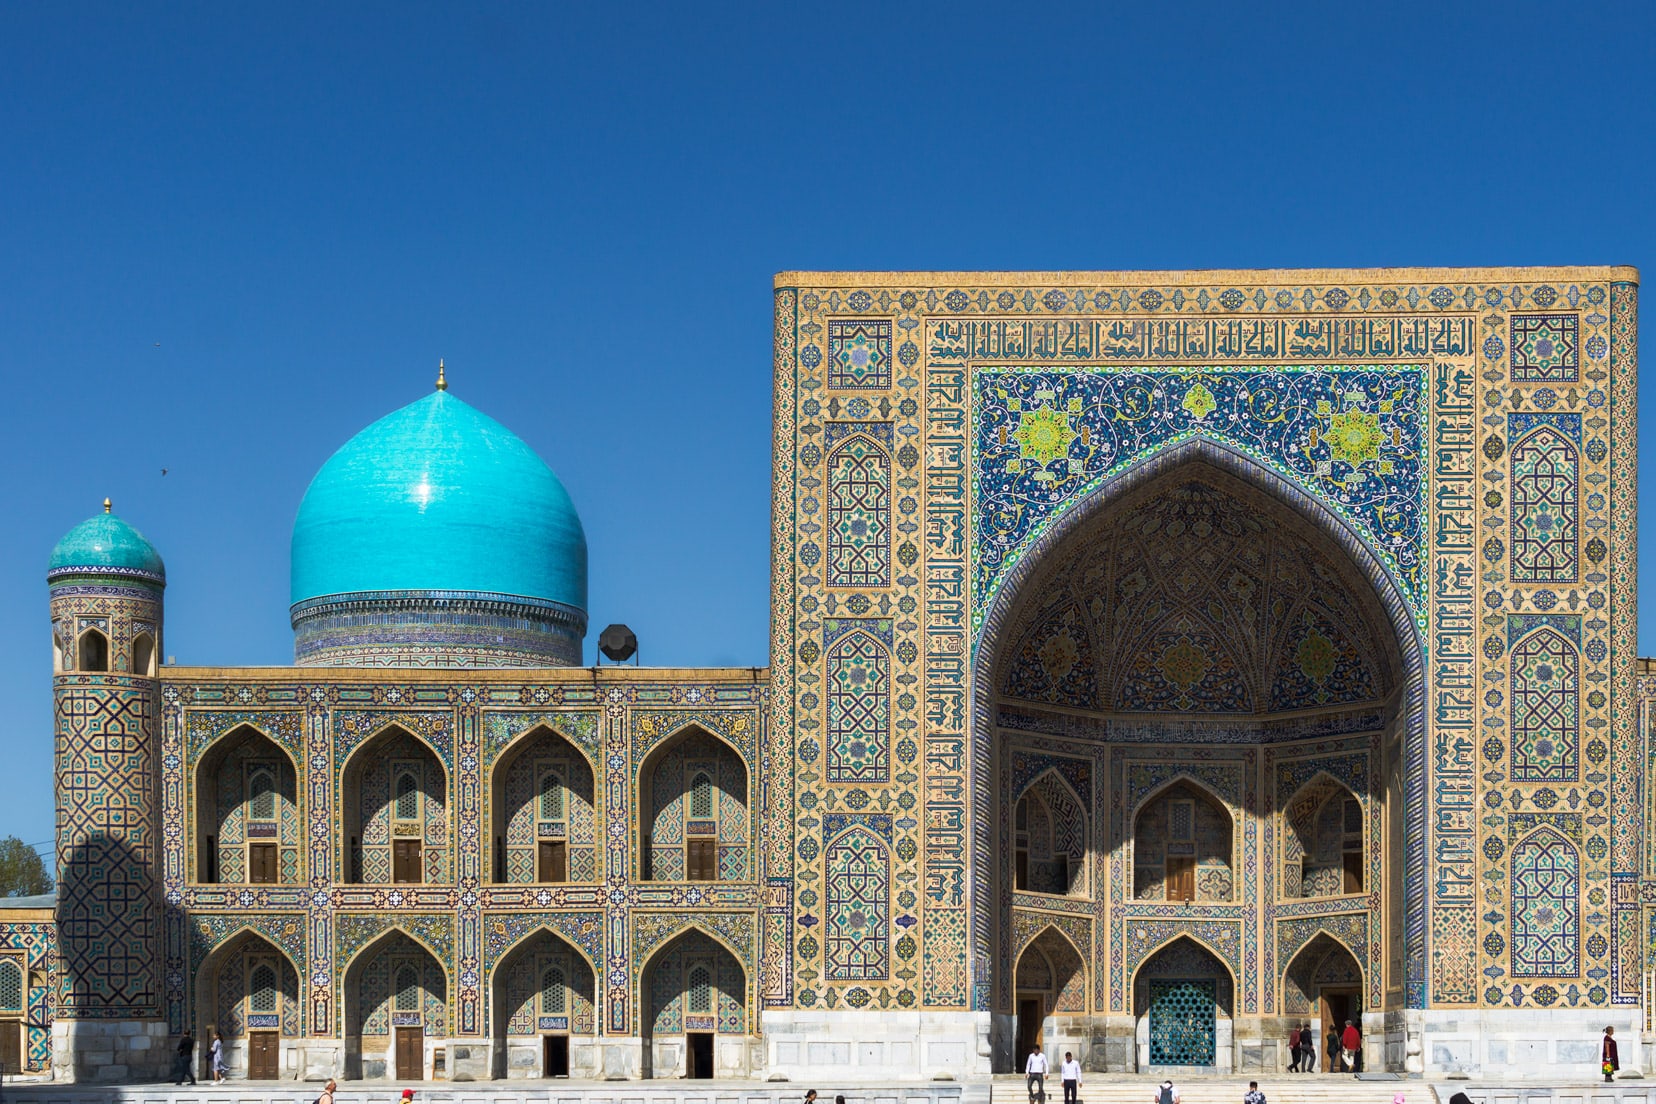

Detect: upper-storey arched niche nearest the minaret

[190,725,305,886]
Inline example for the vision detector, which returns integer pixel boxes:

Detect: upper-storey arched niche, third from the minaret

[489,725,603,886]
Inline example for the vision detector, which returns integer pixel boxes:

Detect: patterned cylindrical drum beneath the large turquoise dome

[291,591,586,669]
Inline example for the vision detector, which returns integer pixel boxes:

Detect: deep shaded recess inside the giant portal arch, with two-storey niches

[994,460,1406,1069]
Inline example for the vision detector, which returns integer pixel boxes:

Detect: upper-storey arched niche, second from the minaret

[341,725,454,886]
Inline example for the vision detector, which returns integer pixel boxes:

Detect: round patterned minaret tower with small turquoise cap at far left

[46,498,169,1081]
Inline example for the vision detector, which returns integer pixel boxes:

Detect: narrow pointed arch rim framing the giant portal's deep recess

[965,435,1429,1011]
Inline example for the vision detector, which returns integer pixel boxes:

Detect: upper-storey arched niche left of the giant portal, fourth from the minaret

[639,725,752,882]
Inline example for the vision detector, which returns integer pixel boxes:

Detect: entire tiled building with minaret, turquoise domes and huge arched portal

[25,268,1656,1079]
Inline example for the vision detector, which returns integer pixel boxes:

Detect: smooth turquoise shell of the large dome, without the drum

[291,391,586,622]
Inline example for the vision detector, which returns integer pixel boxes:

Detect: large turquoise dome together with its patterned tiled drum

[291,389,586,665]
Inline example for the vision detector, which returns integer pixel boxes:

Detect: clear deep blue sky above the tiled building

[0,3,1656,842]
